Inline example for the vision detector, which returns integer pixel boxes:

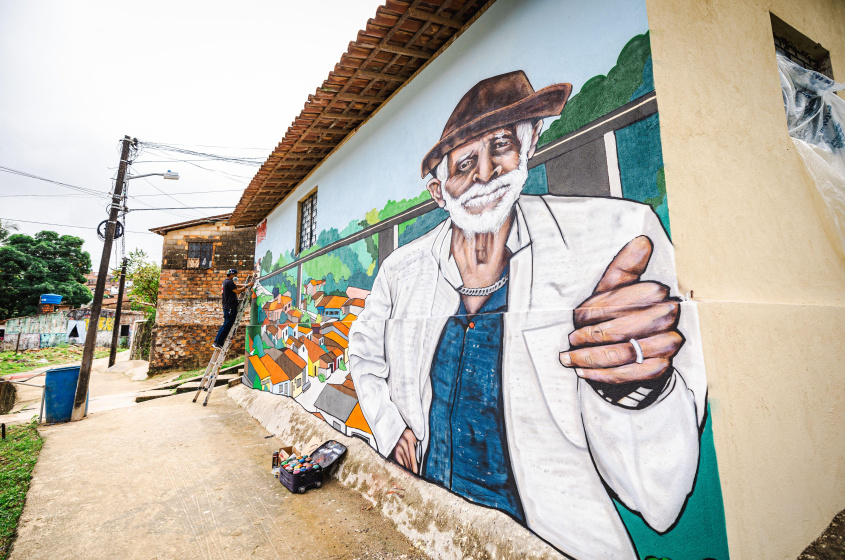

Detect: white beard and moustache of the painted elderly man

[442,155,528,234]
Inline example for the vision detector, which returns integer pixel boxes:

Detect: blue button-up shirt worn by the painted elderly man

[423,271,525,523]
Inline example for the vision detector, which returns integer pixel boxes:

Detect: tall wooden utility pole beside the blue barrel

[70,136,137,422]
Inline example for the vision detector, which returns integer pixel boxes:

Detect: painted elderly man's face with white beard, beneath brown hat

[428,122,541,233]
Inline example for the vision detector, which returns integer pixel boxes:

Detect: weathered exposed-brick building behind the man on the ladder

[150,214,255,372]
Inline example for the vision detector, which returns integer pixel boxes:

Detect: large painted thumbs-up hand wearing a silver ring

[560,236,684,384]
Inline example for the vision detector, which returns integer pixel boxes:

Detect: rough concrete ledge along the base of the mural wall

[227,385,565,560]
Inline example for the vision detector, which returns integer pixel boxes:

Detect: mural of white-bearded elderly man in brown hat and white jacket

[349,71,706,559]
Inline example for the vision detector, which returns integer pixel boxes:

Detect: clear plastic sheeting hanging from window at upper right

[777,54,845,256]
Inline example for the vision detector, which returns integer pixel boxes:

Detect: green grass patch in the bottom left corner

[0,420,43,560]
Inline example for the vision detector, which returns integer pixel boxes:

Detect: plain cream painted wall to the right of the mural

[646,0,845,560]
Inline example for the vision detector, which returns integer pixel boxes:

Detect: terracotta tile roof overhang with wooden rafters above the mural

[227,0,495,228]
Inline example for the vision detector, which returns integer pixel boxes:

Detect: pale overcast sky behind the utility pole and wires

[0,0,381,270]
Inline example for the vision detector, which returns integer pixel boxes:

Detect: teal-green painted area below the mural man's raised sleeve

[616,406,729,560]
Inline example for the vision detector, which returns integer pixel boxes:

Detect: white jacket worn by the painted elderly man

[349,195,706,560]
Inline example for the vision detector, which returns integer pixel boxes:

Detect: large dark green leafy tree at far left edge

[0,231,92,320]
